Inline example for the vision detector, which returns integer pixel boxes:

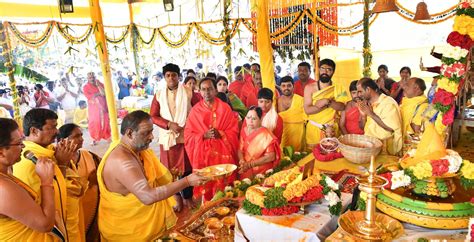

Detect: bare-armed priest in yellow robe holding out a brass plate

[97,110,206,241]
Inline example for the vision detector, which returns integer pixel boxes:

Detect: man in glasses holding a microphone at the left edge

[0,118,58,242]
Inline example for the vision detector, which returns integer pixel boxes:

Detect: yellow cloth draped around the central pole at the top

[257,0,276,94]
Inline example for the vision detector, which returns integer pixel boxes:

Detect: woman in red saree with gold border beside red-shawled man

[237,106,281,179]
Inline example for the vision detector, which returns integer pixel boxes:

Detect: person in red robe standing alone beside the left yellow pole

[84,72,110,145]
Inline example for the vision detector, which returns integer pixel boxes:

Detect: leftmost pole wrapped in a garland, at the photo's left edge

[0,22,21,122]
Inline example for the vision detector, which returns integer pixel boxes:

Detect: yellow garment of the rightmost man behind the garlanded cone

[400,95,428,137]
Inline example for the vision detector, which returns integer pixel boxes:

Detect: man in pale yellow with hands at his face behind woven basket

[357,78,403,155]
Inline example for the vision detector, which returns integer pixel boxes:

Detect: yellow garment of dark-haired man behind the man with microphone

[13,141,67,241]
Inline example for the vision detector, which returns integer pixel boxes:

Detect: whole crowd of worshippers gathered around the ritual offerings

[0,59,440,241]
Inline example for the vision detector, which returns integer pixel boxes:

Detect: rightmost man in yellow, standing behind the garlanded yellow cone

[400,77,428,137]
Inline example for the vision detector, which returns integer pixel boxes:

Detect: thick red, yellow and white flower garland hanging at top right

[431,0,474,136]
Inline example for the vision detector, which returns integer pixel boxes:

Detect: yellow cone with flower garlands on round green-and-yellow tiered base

[377,124,474,229]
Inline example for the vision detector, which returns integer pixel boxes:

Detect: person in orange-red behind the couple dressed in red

[229,66,258,108]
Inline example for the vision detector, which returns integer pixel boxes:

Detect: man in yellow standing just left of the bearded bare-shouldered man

[278,76,307,151]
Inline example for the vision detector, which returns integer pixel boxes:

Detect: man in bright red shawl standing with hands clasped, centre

[184,78,239,200]
